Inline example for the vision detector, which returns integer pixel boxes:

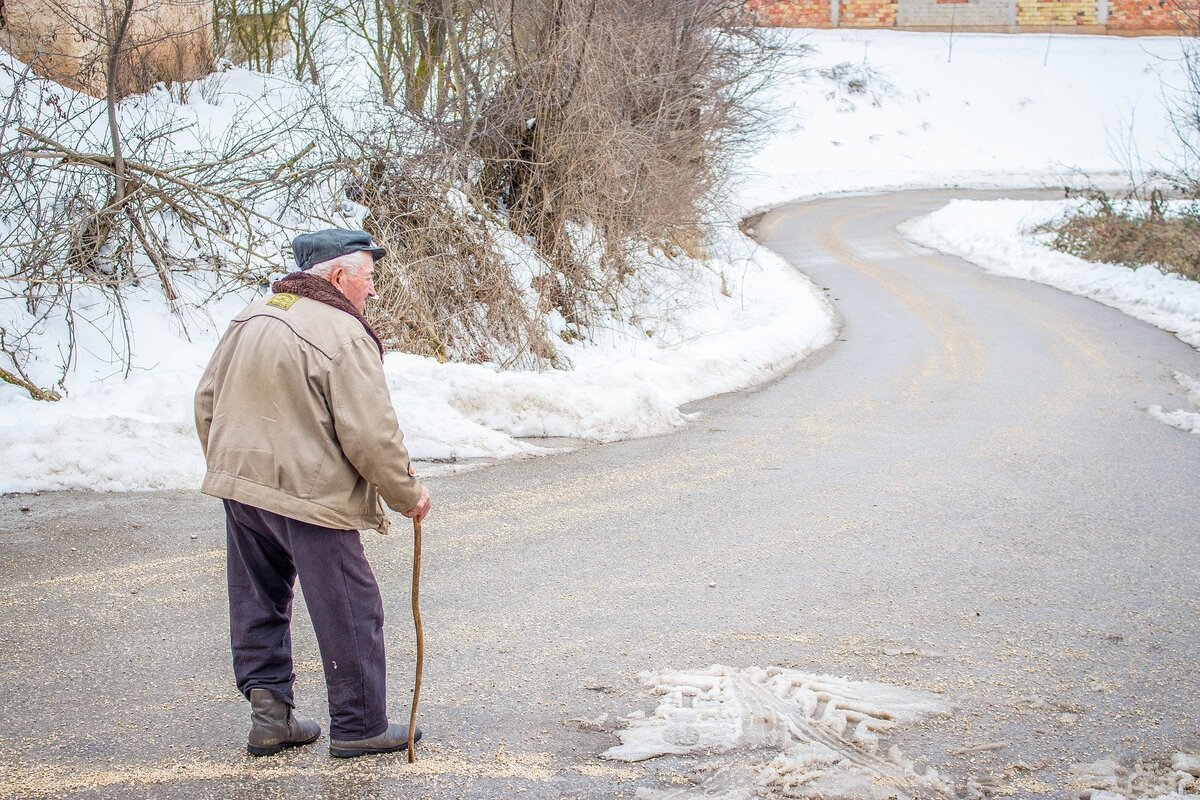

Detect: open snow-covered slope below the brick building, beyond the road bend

[742,30,1182,210]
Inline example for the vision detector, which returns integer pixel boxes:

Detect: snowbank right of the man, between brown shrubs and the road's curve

[386,234,834,458]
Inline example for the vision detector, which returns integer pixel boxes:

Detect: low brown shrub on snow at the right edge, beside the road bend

[1043,192,1200,281]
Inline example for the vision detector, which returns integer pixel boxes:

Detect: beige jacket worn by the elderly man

[196,294,421,533]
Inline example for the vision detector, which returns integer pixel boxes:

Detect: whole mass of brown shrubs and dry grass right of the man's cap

[331,0,776,367]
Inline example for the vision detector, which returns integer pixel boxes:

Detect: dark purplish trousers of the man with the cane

[224,500,388,739]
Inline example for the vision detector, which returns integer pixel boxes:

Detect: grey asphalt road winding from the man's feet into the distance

[0,192,1200,799]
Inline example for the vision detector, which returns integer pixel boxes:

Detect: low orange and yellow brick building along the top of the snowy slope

[746,0,1196,36]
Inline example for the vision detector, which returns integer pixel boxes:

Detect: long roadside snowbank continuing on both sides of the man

[0,225,833,492]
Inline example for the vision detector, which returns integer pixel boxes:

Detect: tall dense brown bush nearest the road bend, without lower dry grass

[473,0,775,324]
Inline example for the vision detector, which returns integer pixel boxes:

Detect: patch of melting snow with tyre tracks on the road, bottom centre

[601,666,950,800]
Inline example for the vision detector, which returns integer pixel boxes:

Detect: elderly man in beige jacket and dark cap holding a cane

[196,229,430,758]
